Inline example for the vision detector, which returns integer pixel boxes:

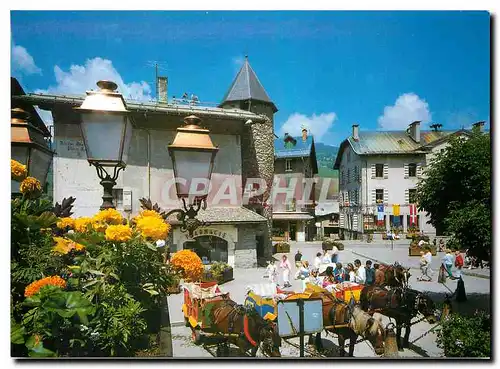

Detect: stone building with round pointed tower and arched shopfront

[13,60,277,268]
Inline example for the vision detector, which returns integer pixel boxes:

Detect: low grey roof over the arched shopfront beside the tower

[164,206,267,225]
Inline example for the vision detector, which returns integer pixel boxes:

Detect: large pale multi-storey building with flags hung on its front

[334,122,476,239]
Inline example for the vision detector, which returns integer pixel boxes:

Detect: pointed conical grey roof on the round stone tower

[220,57,278,112]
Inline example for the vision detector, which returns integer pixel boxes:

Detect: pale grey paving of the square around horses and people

[168,241,490,358]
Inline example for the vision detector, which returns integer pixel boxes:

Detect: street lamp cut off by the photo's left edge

[10,108,54,194]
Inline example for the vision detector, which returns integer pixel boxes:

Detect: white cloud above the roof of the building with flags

[378,92,432,130]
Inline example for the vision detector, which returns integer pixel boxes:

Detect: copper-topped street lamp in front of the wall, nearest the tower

[164,115,219,238]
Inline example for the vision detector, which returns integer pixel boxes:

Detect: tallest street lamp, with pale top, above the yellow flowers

[76,81,132,210]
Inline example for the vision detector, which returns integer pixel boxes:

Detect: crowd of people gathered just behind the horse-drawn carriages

[266,246,384,289]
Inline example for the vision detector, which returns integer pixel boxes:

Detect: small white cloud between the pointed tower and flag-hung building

[280,112,337,142]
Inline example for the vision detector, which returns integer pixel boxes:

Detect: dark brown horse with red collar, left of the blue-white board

[207,298,281,357]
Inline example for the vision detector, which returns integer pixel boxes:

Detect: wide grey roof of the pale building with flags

[334,130,470,169]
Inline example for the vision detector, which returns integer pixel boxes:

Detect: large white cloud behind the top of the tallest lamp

[35,57,152,101]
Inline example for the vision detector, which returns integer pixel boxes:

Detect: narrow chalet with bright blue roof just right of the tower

[273,128,318,241]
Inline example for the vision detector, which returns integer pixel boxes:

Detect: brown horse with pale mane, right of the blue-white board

[309,292,385,357]
